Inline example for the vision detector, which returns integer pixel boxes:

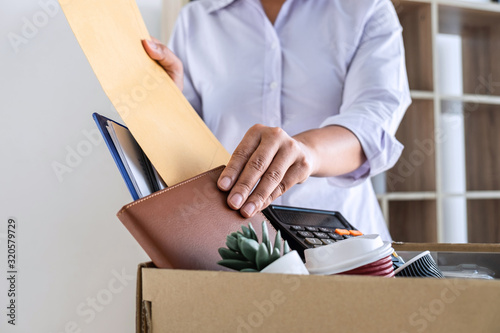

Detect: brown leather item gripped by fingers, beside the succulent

[117,166,276,270]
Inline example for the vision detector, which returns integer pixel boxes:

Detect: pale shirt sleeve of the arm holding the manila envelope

[168,8,203,117]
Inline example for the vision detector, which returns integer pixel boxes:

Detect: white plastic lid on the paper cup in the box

[304,234,394,275]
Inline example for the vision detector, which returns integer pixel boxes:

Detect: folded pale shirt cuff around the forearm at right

[320,112,404,187]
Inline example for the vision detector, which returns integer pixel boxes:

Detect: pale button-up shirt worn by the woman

[169,0,410,240]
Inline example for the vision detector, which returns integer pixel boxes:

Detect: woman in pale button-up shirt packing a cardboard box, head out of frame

[143,0,410,240]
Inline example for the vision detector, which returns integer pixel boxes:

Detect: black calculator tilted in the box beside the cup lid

[262,205,363,258]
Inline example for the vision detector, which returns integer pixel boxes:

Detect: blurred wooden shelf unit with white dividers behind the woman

[376,0,500,242]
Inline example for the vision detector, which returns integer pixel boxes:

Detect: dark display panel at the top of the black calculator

[273,207,346,228]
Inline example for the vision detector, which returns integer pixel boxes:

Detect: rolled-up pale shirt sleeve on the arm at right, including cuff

[321,0,411,187]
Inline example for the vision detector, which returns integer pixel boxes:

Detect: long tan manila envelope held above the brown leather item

[59,0,230,185]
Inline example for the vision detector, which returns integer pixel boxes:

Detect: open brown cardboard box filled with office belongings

[137,243,500,333]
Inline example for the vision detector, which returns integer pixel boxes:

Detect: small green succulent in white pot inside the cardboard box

[218,222,309,274]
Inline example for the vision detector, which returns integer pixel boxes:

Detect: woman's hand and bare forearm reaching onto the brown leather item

[217,125,366,217]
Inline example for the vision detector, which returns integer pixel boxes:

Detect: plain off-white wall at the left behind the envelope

[0,0,166,333]
